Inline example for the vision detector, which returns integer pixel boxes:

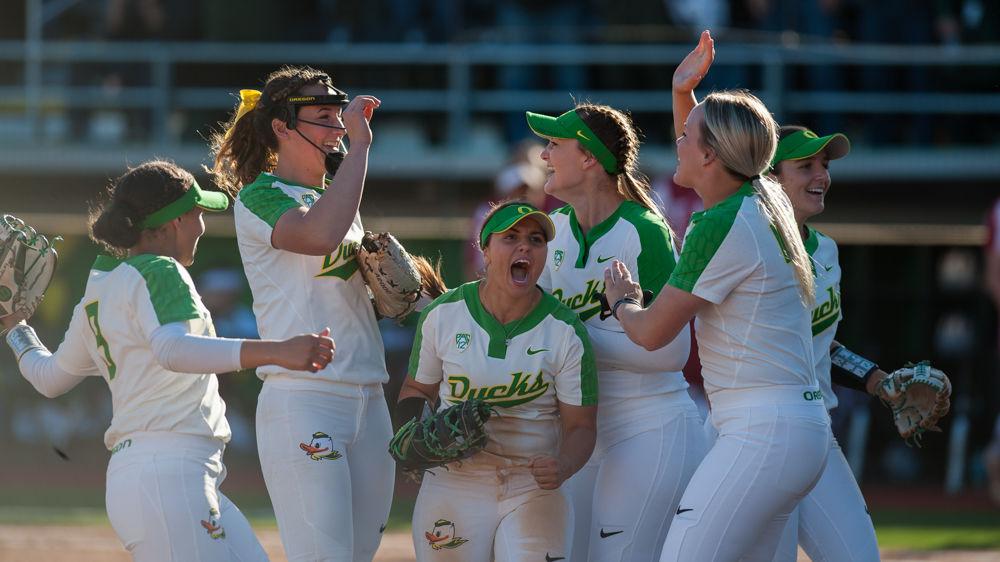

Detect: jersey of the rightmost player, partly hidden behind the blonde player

[805,226,844,410]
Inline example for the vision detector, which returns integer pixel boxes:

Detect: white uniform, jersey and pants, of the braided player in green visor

[540,201,707,562]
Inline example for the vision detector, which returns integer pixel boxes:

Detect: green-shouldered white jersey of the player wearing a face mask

[233,173,389,384]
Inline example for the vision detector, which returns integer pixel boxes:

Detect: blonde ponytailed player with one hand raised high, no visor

[605,32,830,561]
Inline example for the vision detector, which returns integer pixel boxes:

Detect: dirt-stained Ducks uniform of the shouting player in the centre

[409,281,597,562]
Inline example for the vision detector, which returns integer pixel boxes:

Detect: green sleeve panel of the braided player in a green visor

[622,201,677,297]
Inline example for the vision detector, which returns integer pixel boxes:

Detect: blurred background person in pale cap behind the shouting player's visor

[464,140,562,281]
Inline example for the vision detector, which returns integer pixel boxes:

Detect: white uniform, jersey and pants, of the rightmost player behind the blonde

[774,227,879,562]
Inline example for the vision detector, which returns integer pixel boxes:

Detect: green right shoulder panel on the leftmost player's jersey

[125,254,201,326]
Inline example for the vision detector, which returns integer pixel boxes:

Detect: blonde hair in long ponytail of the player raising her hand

[701,90,815,307]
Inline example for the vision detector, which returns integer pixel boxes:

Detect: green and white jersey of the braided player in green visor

[539,201,691,400]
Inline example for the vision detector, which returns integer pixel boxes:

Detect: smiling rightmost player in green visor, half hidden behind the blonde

[760,126,886,562]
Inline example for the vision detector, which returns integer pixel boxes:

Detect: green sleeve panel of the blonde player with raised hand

[667,186,753,293]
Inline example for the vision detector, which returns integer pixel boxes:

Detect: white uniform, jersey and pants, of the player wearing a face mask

[233,173,394,562]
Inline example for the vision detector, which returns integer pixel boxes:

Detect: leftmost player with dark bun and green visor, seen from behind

[0,162,333,562]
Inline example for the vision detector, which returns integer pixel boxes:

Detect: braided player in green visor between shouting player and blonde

[527,104,707,562]
